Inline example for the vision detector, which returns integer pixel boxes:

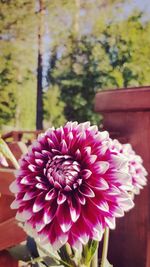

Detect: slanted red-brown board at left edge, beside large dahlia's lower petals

[0,218,26,251]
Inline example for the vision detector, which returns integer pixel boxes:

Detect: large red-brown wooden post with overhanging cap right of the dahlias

[95,87,150,267]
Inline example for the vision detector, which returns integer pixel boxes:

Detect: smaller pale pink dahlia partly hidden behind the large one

[112,140,148,194]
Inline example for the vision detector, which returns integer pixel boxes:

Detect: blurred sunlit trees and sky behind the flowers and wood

[0,0,150,133]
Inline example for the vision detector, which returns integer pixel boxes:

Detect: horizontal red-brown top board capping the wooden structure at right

[95,87,150,112]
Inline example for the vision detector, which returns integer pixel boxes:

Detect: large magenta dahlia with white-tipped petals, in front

[11,122,133,248]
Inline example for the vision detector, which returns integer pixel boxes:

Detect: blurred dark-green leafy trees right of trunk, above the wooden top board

[48,13,150,123]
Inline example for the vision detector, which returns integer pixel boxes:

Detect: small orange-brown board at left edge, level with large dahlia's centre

[0,168,15,196]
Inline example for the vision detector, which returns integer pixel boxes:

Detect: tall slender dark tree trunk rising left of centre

[36,0,44,130]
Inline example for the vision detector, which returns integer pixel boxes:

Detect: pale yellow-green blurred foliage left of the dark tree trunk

[0,0,36,129]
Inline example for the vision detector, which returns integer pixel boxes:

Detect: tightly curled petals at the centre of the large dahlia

[46,155,81,187]
